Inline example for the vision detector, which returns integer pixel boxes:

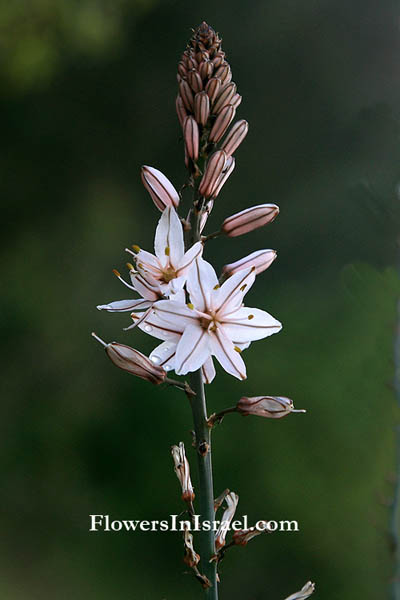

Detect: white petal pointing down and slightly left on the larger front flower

[175,324,211,375]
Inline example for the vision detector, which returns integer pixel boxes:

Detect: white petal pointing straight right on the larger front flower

[221,307,282,342]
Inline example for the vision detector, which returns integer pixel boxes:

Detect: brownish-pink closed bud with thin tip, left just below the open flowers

[92,333,167,385]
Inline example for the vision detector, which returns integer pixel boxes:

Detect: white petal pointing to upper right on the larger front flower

[212,267,256,318]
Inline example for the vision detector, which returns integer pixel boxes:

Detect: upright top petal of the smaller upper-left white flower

[154,206,185,268]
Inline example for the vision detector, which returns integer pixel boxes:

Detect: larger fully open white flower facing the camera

[140,258,282,382]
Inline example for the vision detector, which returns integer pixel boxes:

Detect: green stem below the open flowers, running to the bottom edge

[190,370,218,600]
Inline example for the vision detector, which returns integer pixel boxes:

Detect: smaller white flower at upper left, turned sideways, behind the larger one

[97,206,203,312]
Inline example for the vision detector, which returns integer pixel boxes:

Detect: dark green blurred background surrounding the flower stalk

[0,0,400,600]
